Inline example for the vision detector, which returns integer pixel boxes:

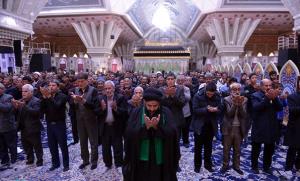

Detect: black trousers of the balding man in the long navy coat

[251,142,275,170]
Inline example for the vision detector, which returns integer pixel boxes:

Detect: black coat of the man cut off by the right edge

[284,92,300,148]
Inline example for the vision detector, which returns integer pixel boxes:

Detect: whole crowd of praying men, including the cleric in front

[0,69,300,181]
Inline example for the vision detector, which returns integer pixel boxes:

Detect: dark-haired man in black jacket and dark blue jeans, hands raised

[40,80,69,172]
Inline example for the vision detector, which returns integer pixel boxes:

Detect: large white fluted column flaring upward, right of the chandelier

[206,18,261,66]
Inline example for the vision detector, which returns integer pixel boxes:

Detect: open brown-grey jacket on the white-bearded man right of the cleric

[221,96,249,138]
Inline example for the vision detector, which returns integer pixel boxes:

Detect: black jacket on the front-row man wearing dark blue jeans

[41,92,67,122]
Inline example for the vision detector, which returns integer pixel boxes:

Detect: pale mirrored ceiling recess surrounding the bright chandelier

[128,0,200,34]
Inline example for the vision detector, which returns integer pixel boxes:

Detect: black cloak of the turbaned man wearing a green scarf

[123,107,180,181]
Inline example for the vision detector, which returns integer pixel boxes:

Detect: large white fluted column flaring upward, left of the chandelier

[72,21,122,72]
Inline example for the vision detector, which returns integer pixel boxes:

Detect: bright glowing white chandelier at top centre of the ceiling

[152,5,171,31]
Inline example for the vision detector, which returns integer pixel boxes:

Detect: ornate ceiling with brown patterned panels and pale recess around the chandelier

[26,0,293,44]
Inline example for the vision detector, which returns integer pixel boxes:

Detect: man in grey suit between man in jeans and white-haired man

[71,73,100,170]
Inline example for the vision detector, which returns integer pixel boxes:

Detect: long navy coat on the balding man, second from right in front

[251,91,282,144]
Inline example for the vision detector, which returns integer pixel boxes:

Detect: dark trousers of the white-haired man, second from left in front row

[21,131,43,162]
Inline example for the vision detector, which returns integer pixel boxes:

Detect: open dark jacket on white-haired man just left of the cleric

[99,94,128,135]
